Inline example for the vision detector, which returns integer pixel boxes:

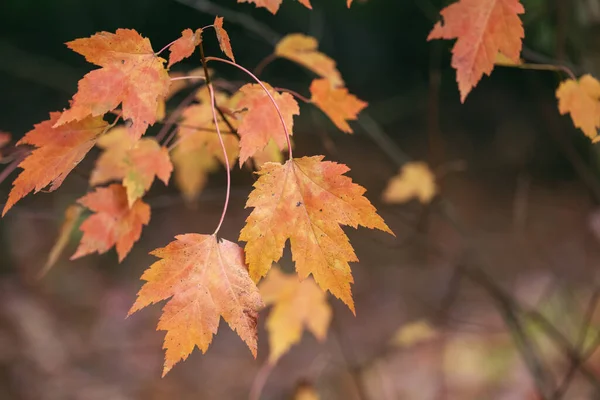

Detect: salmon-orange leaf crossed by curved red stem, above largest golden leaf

[232,82,300,165]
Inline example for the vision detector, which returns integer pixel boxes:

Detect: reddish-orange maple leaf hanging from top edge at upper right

[427,0,525,102]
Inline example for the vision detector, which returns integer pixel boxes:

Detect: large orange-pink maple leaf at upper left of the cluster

[55,29,171,138]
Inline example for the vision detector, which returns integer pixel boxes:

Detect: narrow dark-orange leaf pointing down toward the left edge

[2,112,108,216]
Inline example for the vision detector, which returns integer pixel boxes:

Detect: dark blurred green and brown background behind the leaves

[0,0,600,400]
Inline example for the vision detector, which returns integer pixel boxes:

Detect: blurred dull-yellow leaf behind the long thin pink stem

[172,94,239,203]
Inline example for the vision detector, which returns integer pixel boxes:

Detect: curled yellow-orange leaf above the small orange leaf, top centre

[275,33,344,87]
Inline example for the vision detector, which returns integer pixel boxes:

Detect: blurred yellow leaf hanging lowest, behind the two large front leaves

[258,267,331,364]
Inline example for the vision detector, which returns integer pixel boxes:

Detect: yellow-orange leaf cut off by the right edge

[556,74,600,143]
